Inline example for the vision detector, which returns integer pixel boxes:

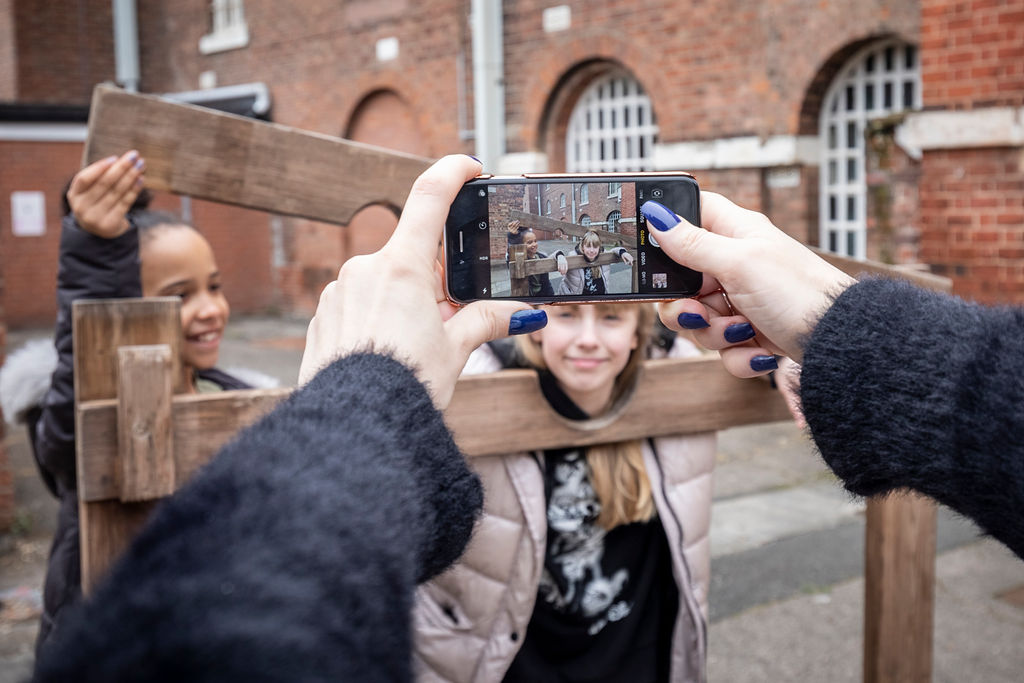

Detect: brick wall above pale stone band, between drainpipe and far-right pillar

[504,0,920,152]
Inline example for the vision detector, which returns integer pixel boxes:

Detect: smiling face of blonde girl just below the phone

[531,304,639,417]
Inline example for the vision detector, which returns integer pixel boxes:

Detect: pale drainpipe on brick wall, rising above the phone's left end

[470,0,505,169]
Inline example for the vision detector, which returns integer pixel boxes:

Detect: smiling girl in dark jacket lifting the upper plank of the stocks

[26,152,273,646]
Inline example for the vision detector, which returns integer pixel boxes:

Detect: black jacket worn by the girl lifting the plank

[27,215,249,644]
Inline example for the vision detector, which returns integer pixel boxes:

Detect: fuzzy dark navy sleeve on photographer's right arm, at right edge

[801,280,1024,557]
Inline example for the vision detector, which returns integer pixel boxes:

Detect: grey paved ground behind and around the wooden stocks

[0,318,1024,683]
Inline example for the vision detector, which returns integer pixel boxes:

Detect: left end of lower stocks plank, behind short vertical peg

[78,388,292,502]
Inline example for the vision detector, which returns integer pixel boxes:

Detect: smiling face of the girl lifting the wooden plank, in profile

[139,225,230,370]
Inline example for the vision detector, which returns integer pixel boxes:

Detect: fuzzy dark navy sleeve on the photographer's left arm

[36,354,482,682]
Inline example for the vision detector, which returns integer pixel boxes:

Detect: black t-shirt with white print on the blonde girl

[504,376,679,683]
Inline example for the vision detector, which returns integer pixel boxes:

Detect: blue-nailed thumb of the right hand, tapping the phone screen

[640,201,735,278]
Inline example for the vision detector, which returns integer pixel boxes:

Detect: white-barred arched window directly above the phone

[565,72,657,173]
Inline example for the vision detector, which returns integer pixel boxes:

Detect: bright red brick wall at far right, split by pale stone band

[920,0,1024,304]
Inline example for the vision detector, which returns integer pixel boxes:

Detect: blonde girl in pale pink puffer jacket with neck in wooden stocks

[414,304,716,683]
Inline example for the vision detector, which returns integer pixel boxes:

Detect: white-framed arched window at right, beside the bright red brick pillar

[818,40,922,259]
